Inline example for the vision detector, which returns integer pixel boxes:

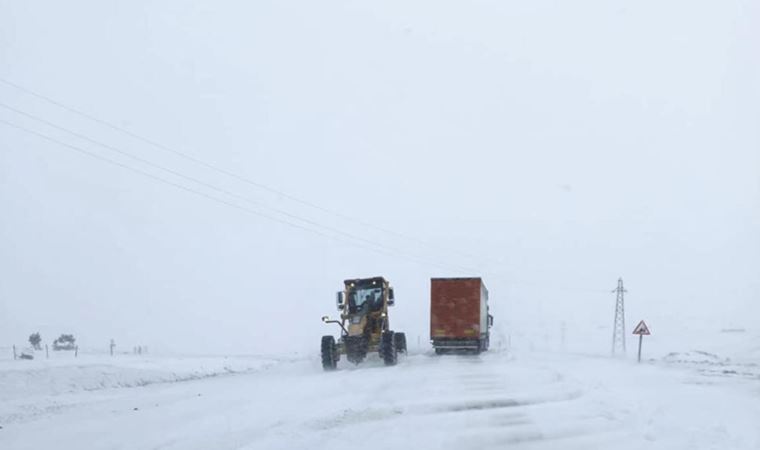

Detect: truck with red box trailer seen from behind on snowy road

[430,278,493,354]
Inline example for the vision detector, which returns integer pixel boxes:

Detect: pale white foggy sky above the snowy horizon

[0,0,760,353]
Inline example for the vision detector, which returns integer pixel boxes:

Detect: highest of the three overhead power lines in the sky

[0,78,492,268]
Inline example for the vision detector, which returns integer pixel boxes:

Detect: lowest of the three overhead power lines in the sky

[0,119,478,270]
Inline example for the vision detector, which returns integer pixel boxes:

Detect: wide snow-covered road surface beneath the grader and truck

[0,353,760,450]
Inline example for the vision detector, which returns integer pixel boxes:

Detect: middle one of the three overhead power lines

[0,102,480,272]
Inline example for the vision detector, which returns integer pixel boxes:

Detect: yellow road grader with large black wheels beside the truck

[321,277,406,371]
